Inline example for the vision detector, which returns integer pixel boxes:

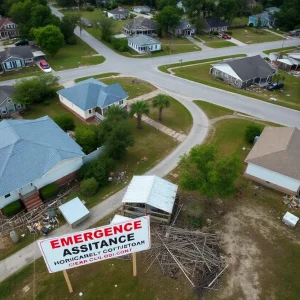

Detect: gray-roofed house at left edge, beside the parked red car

[0,46,35,72]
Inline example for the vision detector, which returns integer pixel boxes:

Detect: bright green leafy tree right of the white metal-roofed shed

[179,145,240,197]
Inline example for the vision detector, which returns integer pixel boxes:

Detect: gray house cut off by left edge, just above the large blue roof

[0,85,25,119]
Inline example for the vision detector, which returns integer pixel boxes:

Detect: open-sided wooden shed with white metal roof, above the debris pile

[121,176,178,224]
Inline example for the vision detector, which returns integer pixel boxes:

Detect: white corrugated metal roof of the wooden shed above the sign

[122,176,178,213]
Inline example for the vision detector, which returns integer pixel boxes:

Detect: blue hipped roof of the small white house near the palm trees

[57,78,128,111]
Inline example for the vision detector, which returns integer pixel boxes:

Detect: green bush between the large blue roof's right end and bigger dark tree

[75,125,99,154]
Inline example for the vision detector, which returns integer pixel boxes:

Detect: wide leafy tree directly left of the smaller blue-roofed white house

[12,74,59,105]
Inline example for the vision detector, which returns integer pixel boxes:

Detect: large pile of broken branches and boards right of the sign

[145,226,227,296]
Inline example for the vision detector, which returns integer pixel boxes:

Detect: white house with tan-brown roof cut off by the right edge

[244,127,300,195]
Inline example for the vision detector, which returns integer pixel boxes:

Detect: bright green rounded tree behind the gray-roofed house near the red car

[33,25,64,56]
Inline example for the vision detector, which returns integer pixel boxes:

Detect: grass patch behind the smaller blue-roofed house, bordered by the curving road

[101,77,156,99]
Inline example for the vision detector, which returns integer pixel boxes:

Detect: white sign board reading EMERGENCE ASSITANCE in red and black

[37,216,151,273]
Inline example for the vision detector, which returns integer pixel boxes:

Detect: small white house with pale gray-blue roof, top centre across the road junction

[128,34,161,54]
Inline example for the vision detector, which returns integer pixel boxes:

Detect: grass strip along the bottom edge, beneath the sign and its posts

[0,253,196,300]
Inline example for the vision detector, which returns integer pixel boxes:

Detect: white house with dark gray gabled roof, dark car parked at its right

[210,55,276,89]
